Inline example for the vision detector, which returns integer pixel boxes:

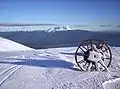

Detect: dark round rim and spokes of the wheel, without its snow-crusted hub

[75,39,112,71]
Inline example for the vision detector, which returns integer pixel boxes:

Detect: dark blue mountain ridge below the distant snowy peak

[0,27,120,49]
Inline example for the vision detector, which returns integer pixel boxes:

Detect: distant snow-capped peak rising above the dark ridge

[47,26,72,32]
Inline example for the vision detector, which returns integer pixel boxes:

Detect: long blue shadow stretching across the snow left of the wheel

[0,59,78,71]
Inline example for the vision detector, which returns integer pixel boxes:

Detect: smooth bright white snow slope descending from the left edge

[0,37,33,51]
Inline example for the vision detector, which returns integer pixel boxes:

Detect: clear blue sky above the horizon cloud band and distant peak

[0,0,120,25]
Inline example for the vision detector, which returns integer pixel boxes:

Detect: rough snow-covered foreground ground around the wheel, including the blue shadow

[0,38,120,89]
